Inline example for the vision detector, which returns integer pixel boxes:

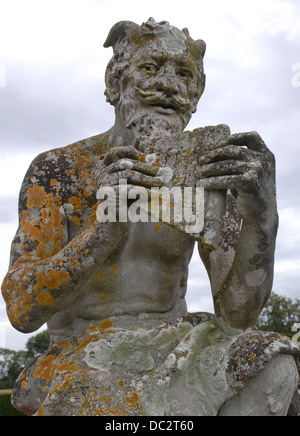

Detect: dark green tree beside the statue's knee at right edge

[256,293,300,338]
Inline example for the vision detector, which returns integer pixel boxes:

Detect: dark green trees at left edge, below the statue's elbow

[0,331,50,389]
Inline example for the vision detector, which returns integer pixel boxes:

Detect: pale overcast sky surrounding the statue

[0,0,300,349]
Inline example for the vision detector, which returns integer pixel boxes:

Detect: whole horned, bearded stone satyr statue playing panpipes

[2,19,300,416]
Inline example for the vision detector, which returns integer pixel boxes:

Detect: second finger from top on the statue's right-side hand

[199,145,256,165]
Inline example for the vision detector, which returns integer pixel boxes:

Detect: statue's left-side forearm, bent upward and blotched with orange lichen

[2,222,124,332]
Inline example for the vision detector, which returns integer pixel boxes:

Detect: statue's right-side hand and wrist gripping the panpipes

[200,132,276,220]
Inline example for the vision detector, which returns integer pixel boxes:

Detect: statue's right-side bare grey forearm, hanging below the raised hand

[214,210,278,329]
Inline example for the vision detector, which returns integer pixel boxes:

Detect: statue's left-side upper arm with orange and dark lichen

[10,155,68,268]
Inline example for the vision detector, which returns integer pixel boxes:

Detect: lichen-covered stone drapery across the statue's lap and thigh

[13,314,299,416]
